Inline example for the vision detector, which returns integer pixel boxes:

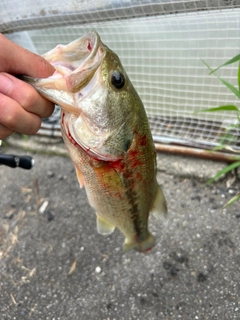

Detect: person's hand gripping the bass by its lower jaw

[0,34,55,139]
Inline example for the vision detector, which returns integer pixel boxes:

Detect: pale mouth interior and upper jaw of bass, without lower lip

[43,31,105,93]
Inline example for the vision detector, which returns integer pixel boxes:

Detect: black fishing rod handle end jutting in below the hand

[0,154,34,169]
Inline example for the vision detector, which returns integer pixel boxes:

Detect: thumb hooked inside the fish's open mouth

[0,34,55,78]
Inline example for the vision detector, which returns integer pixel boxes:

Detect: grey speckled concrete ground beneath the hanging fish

[0,138,240,320]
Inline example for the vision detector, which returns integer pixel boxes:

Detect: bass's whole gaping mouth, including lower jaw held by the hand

[21,31,106,116]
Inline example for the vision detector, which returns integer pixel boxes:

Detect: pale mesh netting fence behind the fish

[0,0,240,150]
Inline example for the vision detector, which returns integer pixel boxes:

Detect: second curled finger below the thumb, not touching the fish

[0,93,41,134]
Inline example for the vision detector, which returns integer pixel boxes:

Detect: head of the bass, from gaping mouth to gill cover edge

[24,31,141,161]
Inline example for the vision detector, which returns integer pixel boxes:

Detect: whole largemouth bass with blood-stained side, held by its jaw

[24,31,167,252]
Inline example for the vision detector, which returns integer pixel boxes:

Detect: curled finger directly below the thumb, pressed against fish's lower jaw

[0,73,54,118]
